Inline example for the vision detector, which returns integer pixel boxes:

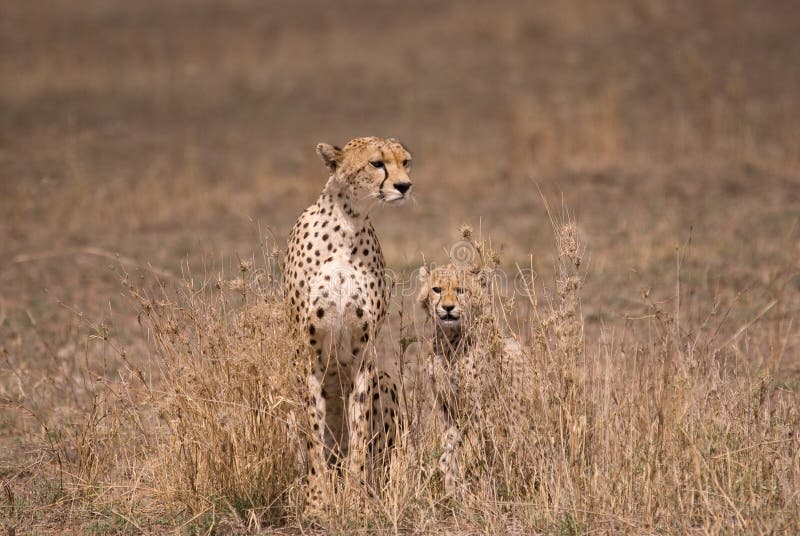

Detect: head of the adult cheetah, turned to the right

[317,137,411,210]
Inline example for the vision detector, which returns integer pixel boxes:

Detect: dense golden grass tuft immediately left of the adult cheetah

[119,261,302,526]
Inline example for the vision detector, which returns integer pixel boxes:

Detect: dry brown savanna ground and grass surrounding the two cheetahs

[0,0,800,533]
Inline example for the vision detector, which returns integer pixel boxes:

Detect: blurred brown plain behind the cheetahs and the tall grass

[0,0,800,382]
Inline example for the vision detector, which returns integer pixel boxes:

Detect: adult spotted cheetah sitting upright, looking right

[284,137,411,511]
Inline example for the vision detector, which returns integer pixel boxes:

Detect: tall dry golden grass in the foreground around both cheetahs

[5,217,800,534]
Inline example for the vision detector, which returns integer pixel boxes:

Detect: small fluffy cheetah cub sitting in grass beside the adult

[417,264,524,494]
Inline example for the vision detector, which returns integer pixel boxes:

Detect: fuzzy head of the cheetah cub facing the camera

[417,264,485,331]
